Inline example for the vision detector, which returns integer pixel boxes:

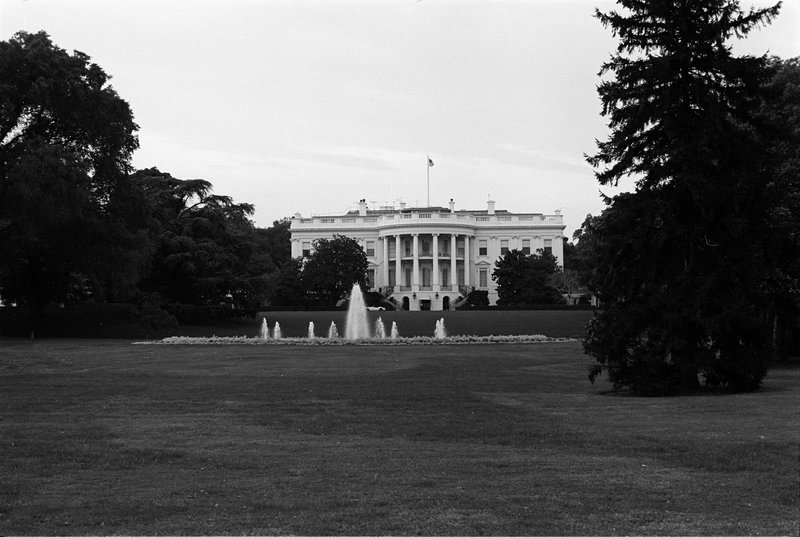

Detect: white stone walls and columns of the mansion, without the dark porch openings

[291,202,565,310]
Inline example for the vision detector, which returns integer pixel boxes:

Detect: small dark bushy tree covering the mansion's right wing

[492,250,564,306]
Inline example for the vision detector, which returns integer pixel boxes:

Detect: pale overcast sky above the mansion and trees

[0,0,800,236]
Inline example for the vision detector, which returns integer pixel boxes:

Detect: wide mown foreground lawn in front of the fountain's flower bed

[0,338,800,535]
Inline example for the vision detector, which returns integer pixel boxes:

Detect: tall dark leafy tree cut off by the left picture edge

[0,32,142,328]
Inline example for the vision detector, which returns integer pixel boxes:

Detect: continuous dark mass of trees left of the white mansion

[0,32,291,329]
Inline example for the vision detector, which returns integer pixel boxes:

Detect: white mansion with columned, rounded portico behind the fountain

[290,200,566,311]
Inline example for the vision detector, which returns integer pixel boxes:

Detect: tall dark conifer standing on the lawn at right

[584,0,780,394]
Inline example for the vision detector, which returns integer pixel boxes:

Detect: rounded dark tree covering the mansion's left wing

[302,235,369,308]
